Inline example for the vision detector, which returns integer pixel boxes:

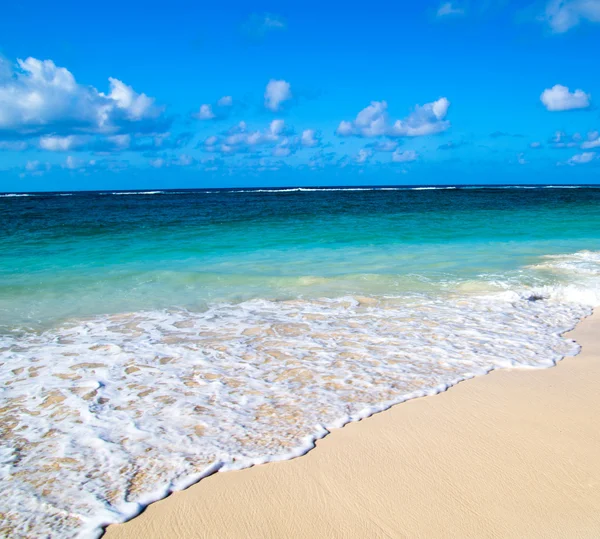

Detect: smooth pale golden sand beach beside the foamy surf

[105,312,600,539]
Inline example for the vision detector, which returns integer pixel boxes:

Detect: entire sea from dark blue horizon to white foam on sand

[0,186,600,537]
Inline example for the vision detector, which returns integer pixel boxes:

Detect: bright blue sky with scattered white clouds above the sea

[0,0,600,191]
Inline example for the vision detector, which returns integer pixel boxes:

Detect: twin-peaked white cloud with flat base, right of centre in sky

[336,97,450,138]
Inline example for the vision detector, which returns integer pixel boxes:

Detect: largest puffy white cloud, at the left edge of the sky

[0,58,171,151]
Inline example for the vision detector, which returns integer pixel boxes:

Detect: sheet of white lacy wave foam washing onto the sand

[0,280,589,537]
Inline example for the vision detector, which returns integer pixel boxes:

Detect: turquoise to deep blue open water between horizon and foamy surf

[0,188,600,329]
